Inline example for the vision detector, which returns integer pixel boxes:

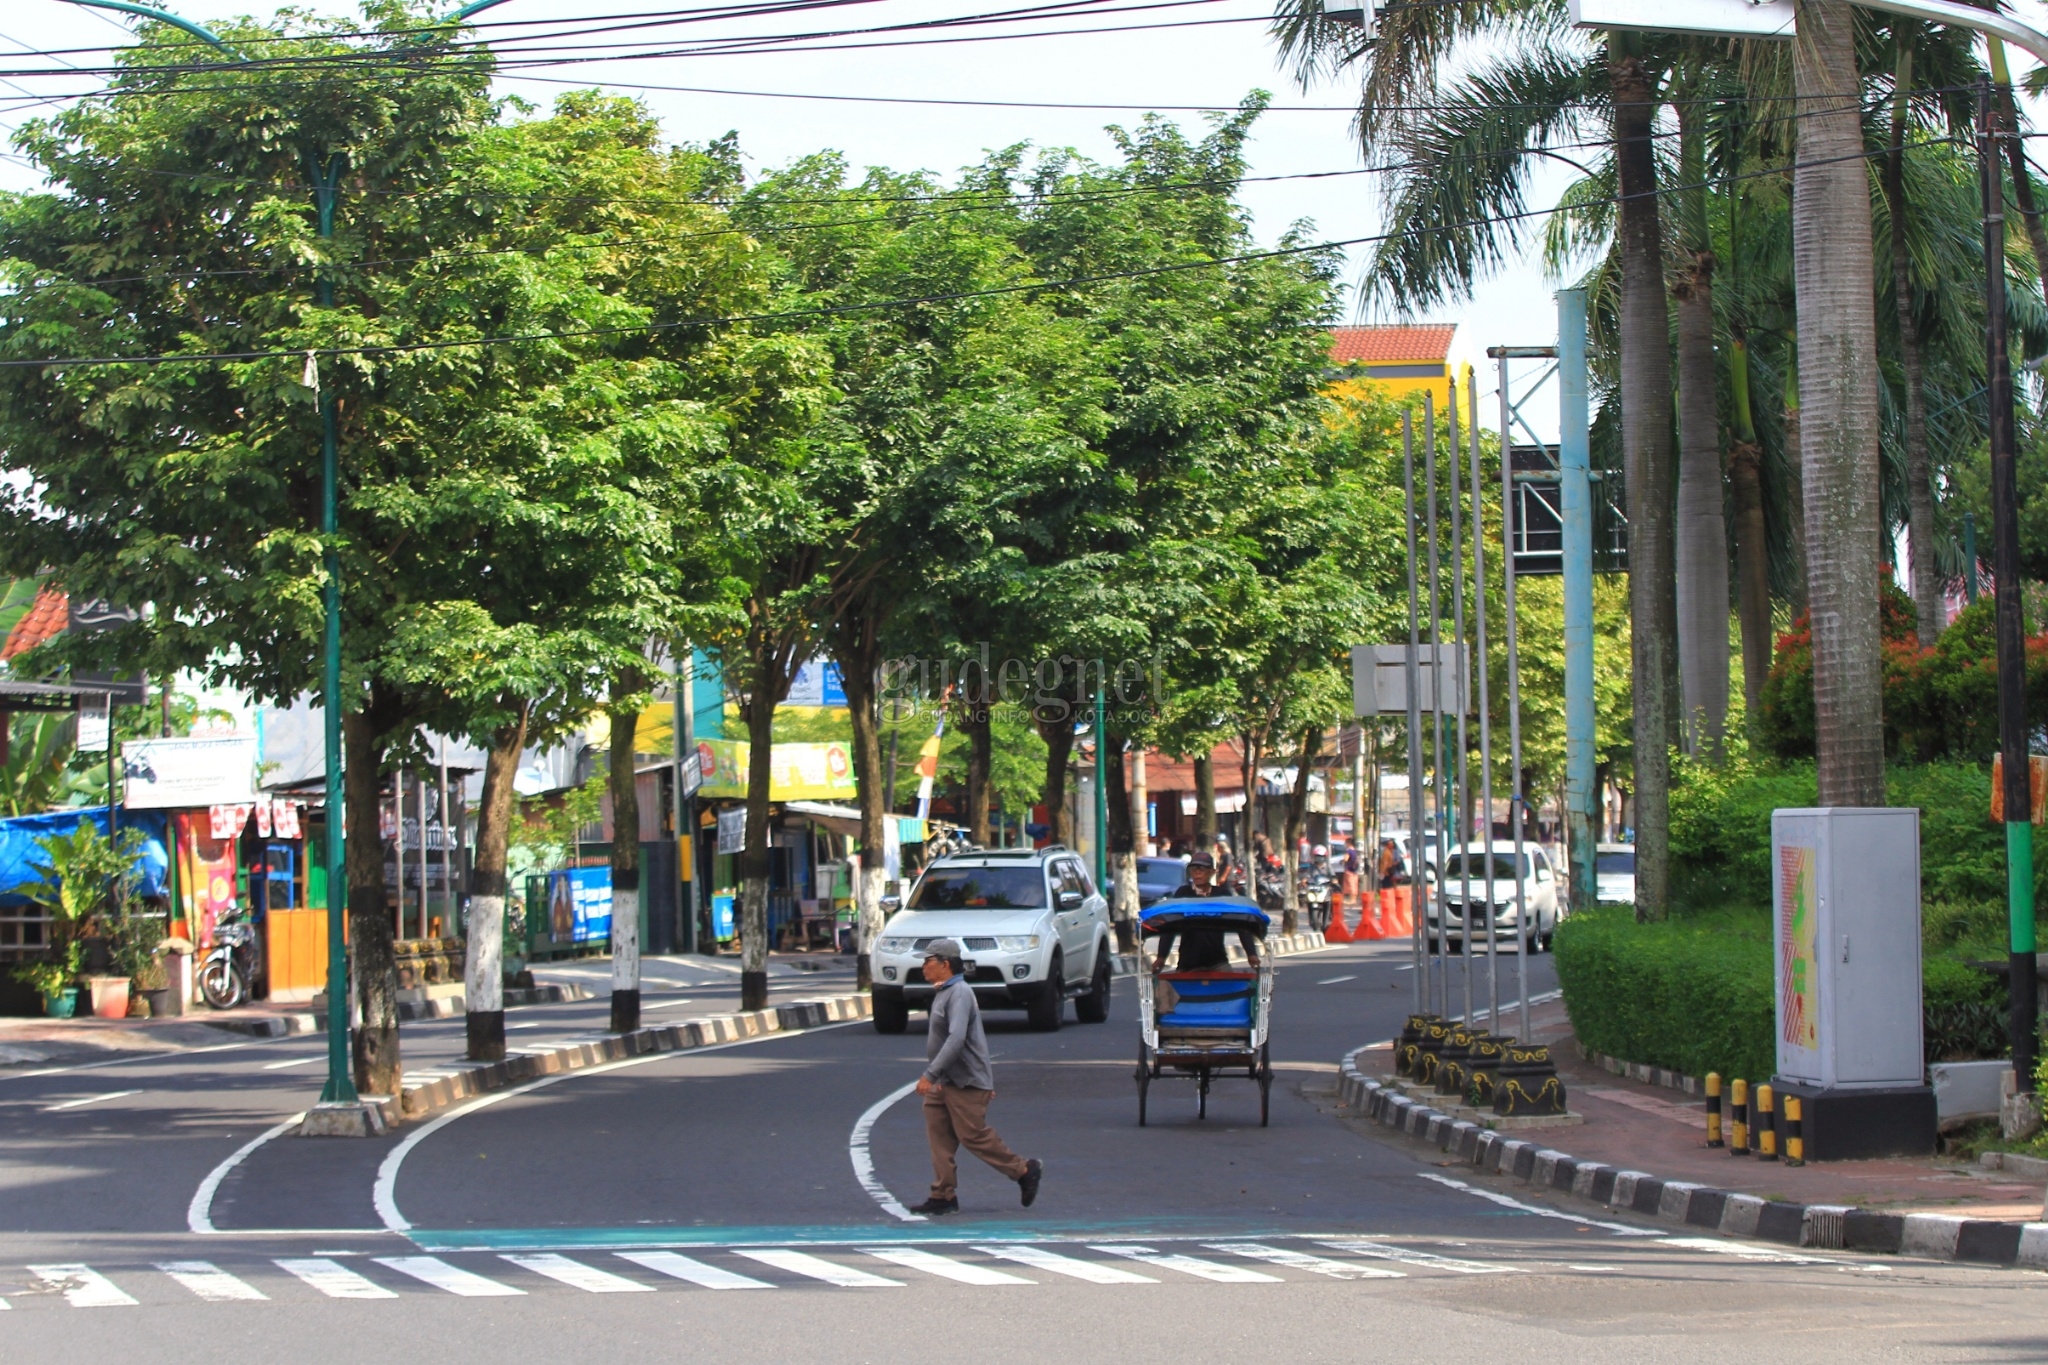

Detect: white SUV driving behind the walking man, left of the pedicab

[872,843,1112,1033]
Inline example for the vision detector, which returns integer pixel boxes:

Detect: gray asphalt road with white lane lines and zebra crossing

[0,945,2048,1363]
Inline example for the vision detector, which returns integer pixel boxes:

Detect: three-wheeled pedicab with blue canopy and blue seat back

[1139,896,1274,1128]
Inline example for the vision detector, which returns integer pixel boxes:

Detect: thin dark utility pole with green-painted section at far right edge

[1976,78,2038,1095]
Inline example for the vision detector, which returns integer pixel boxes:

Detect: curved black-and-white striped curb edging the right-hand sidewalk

[1337,1050,2048,1269]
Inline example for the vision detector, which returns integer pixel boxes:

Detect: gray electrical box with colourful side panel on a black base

[1772,806,1935,1160]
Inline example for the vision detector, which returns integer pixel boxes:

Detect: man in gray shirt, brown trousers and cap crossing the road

[911,939,1044,1216]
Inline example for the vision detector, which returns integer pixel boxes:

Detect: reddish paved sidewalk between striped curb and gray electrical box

[1356,986,2048,1224]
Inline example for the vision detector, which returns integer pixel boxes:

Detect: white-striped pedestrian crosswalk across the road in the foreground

[0,1234,1777,1310]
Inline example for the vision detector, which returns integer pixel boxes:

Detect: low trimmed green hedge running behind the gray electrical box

[1556,907,2007,1081]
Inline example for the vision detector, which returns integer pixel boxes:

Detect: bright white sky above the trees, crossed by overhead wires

[0,0,2048,438]
